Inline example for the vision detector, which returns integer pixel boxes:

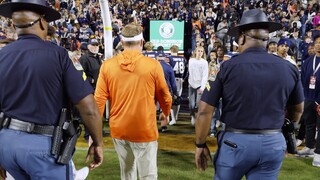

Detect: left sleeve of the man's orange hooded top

[94,61,109,117]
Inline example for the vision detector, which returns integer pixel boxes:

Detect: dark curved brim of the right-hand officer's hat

[227,22,282,37]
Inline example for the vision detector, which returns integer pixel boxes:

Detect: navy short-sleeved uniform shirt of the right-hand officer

[201,48,304,129]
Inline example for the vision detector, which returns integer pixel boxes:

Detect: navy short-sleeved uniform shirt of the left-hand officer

[0,35,93,125]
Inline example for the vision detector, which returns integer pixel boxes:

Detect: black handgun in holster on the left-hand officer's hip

[56,121,81,165]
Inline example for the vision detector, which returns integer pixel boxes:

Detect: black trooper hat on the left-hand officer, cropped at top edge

[0,0,61,22]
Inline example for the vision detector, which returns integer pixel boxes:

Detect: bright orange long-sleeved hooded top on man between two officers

[94,50,172,142]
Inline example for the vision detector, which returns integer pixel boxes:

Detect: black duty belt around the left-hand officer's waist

[0,117,54,136]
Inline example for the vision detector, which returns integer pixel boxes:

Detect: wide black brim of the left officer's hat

[0,2,61,22]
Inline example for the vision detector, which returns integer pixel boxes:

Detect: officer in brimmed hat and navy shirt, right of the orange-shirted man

[195,9,304,180]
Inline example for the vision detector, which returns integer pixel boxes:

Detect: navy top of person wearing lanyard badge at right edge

[301,56,320,103]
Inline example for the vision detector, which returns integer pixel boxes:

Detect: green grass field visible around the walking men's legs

[73,149,320,180]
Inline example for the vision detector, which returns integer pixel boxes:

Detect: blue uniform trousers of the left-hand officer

[0,129,73,180]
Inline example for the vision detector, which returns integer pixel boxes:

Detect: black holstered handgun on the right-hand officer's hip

[282,119,298,154]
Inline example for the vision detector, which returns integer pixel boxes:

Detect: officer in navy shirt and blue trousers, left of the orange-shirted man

[0,0,103,179]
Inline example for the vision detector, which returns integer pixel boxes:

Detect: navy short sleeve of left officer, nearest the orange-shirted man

[63,53,93,104]
